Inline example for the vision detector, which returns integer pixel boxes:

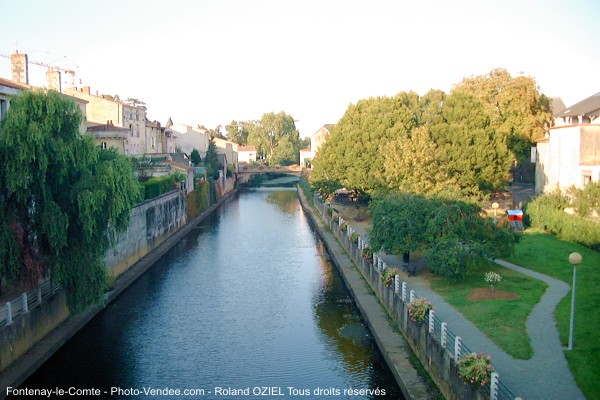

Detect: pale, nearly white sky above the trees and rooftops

[0,0,600,137]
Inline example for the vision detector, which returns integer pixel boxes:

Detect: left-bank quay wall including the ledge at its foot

[0,189,237,400]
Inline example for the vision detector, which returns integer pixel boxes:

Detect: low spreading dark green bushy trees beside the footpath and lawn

[369,193,516,279]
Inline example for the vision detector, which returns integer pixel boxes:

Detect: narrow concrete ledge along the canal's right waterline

[298,188,437,400]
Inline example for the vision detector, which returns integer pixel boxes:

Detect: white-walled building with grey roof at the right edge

[534,93,600,194]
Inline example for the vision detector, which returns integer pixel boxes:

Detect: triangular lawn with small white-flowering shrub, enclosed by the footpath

[430,266,547,359]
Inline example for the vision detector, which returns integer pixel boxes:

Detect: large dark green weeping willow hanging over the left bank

[0,91,141,311]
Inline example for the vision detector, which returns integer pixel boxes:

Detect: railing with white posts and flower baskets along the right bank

[313,192,516,400]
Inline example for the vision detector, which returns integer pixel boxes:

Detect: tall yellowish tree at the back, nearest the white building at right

[452,68,552,164]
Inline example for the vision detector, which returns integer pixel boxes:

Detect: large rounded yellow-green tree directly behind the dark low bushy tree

[382,92,513,196]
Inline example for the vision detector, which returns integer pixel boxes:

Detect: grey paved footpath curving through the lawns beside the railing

[347,214,585,400]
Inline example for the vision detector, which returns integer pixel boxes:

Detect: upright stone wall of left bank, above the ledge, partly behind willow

[0,191,186,372]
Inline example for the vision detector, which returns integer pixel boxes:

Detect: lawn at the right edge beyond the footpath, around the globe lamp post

[507,229,600,399]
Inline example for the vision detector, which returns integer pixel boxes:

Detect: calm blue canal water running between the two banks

[21,188,402,399]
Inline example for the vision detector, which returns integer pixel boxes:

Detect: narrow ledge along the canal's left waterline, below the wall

[0,189,237,399]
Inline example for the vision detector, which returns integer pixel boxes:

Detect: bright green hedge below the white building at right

[525,190,600,250]
